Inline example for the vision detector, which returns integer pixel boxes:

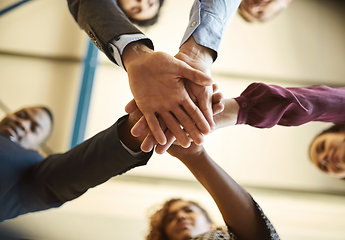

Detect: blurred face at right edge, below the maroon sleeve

[309,132,345,178]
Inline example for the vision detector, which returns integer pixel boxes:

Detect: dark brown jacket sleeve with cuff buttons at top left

[67,0,142,62]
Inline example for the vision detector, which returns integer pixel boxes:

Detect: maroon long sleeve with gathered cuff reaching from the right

[235,83,345,128]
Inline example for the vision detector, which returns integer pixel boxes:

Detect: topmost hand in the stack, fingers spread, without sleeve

[123,44,212,147]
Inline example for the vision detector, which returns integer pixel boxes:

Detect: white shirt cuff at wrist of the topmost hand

[108,33,153,69]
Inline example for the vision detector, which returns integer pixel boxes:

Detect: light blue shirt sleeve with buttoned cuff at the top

[181,0,241,59]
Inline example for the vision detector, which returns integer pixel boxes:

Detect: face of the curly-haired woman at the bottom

[164,201,212,240]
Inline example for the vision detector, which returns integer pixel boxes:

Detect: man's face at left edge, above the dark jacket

[0,107,52,150]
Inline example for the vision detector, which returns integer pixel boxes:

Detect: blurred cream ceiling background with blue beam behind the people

[0,0,345,240]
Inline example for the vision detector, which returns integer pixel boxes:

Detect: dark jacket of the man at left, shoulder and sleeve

[0,116,152,221]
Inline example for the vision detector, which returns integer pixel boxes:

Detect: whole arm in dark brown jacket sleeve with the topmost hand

[69,0,212,146]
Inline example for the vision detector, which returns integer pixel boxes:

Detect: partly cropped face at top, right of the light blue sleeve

[238,0,292,22]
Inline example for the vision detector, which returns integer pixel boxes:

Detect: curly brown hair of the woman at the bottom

[146,198,213,240]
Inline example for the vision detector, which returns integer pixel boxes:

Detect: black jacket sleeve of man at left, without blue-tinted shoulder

[23,116,152,211]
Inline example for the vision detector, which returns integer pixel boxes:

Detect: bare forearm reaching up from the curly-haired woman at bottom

[168,144,270,239]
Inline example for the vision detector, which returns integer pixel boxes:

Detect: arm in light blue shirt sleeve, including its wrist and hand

[171,0,241,141]
